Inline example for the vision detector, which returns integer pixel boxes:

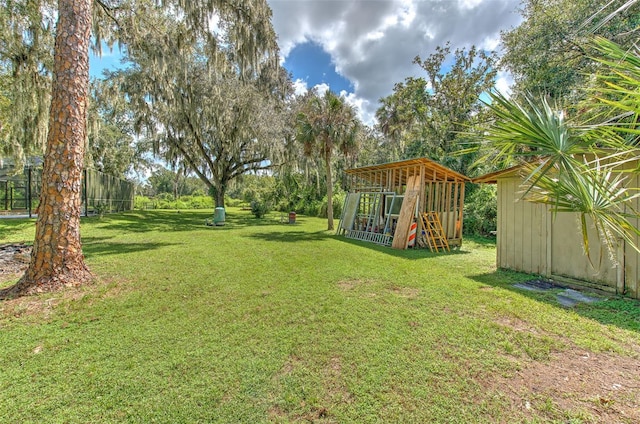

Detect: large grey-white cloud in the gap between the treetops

[268,0,521,121]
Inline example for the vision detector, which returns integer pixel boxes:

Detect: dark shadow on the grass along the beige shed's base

[469,270,640,333]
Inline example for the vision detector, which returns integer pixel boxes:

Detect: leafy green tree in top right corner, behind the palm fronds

[501,0,640,104]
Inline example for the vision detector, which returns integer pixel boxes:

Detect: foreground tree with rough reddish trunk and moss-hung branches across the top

[0,0,275,298]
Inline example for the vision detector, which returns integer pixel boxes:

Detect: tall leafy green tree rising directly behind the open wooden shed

[377,45,497,173]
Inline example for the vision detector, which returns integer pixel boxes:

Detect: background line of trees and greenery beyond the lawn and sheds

[0,0,640,238]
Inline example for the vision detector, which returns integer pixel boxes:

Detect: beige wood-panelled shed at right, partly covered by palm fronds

[473,161,640,299]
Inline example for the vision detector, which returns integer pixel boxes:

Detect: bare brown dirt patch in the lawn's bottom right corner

[483,348,640,423]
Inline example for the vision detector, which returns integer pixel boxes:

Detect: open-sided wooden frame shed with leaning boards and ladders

[338,158,471,249]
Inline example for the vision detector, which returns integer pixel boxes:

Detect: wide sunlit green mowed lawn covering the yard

[0,209,640,423]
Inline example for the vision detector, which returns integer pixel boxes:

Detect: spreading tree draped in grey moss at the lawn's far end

[111,9,288,206]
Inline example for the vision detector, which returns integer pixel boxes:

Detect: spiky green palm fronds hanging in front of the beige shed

[481,38,640,256]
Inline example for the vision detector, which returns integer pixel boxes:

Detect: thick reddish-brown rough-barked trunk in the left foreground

[0,0,92,298]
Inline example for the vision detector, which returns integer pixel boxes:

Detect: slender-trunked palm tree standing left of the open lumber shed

[297,90,360,230]
